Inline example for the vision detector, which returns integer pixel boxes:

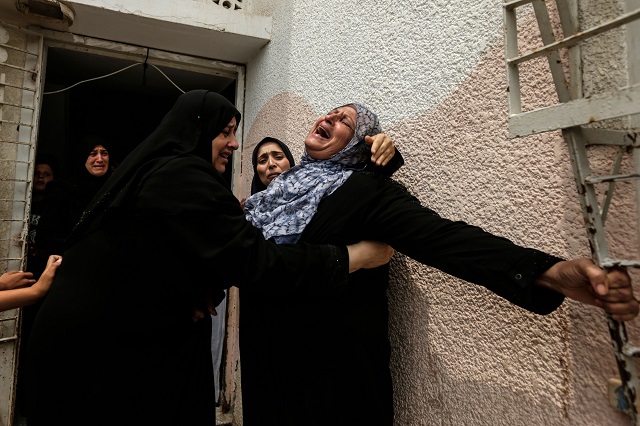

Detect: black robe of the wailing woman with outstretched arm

[240,173,563,426]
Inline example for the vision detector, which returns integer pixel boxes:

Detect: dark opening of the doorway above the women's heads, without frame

[37,47,237,181]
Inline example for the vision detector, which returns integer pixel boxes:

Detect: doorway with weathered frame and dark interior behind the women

[13,34,244,424]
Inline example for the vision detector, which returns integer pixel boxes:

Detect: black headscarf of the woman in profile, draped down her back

[70,90,240,241]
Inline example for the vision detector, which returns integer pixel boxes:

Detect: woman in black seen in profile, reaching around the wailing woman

[29,90,389,426]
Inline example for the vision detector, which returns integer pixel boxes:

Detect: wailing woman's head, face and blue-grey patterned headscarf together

[244,103,382,244]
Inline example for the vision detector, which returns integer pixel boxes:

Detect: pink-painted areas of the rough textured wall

[242,2,637,426]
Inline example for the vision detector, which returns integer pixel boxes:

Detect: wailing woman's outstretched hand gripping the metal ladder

[537,259,639,321]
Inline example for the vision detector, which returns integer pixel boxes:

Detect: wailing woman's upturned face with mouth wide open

[304,106,356,160]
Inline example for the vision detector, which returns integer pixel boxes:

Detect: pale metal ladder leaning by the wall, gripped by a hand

[503,0,640,425]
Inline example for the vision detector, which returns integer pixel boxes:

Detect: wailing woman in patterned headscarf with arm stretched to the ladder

[240,104,638,426]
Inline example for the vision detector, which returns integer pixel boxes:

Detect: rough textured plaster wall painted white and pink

[240,0,636,426]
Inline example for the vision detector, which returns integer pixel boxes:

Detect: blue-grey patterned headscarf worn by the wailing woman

[244,103,382,244]
